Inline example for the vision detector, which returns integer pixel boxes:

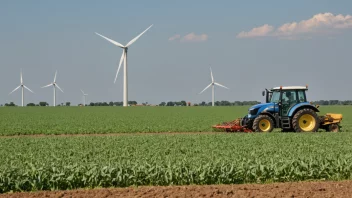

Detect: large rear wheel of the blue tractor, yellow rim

[292,109,320,132]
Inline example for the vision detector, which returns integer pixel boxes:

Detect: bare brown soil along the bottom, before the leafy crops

[0,181,352,198]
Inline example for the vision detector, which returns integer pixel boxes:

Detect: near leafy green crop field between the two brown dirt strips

[0,133,352,193]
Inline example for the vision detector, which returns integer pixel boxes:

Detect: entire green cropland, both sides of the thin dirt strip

[0,106,352,193]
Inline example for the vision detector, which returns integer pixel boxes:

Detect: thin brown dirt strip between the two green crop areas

[0,132,230,138]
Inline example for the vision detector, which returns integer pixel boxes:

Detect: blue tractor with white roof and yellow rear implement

[240,86,342,132]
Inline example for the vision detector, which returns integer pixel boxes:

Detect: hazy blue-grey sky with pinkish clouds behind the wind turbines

[0,0,352,105]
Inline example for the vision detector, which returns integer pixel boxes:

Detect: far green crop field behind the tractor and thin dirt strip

[0,106,352,135]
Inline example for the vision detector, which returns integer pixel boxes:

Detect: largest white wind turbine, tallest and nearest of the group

[95,25,153,107]
